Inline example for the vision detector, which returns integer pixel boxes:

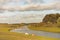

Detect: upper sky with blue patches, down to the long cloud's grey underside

[0,0,60,10]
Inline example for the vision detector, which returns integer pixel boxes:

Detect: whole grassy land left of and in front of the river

[0,24,60,40]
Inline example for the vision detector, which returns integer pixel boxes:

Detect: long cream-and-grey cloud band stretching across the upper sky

[2,0,60,10]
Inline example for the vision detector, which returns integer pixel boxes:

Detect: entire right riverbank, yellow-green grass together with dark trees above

[28,14,60,33]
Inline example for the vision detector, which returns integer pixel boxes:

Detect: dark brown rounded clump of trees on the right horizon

[42,13,60,23]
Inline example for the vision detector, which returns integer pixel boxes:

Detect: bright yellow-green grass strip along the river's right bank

[28,27,60,33]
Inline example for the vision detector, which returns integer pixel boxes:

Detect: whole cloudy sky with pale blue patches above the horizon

[0,0,60,23]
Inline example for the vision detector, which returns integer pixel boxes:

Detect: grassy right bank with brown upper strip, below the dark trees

[28,23,60,33]
